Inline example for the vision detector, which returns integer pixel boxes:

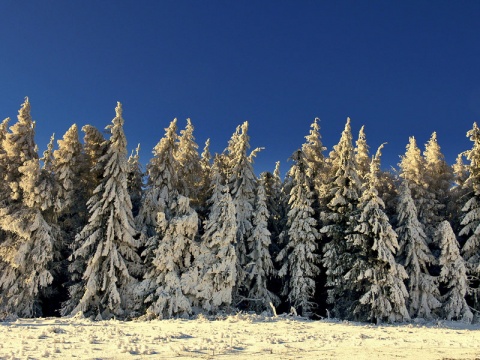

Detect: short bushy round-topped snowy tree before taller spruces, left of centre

[141,195,198,319]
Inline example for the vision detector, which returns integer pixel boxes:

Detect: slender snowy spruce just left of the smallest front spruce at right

[395,181,441,319]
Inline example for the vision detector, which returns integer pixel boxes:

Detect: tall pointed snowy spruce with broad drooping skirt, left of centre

[64,103,140,319]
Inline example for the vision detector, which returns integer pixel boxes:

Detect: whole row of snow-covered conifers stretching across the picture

[0,98,480,323]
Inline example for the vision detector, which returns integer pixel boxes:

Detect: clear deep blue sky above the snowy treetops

[0,0,480,173]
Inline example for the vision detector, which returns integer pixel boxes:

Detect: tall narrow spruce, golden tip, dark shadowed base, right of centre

[321,118,361,317]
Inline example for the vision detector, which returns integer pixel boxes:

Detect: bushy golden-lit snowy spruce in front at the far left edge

[0,159,61,317]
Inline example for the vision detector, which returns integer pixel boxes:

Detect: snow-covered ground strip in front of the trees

[0,314,480,360]
